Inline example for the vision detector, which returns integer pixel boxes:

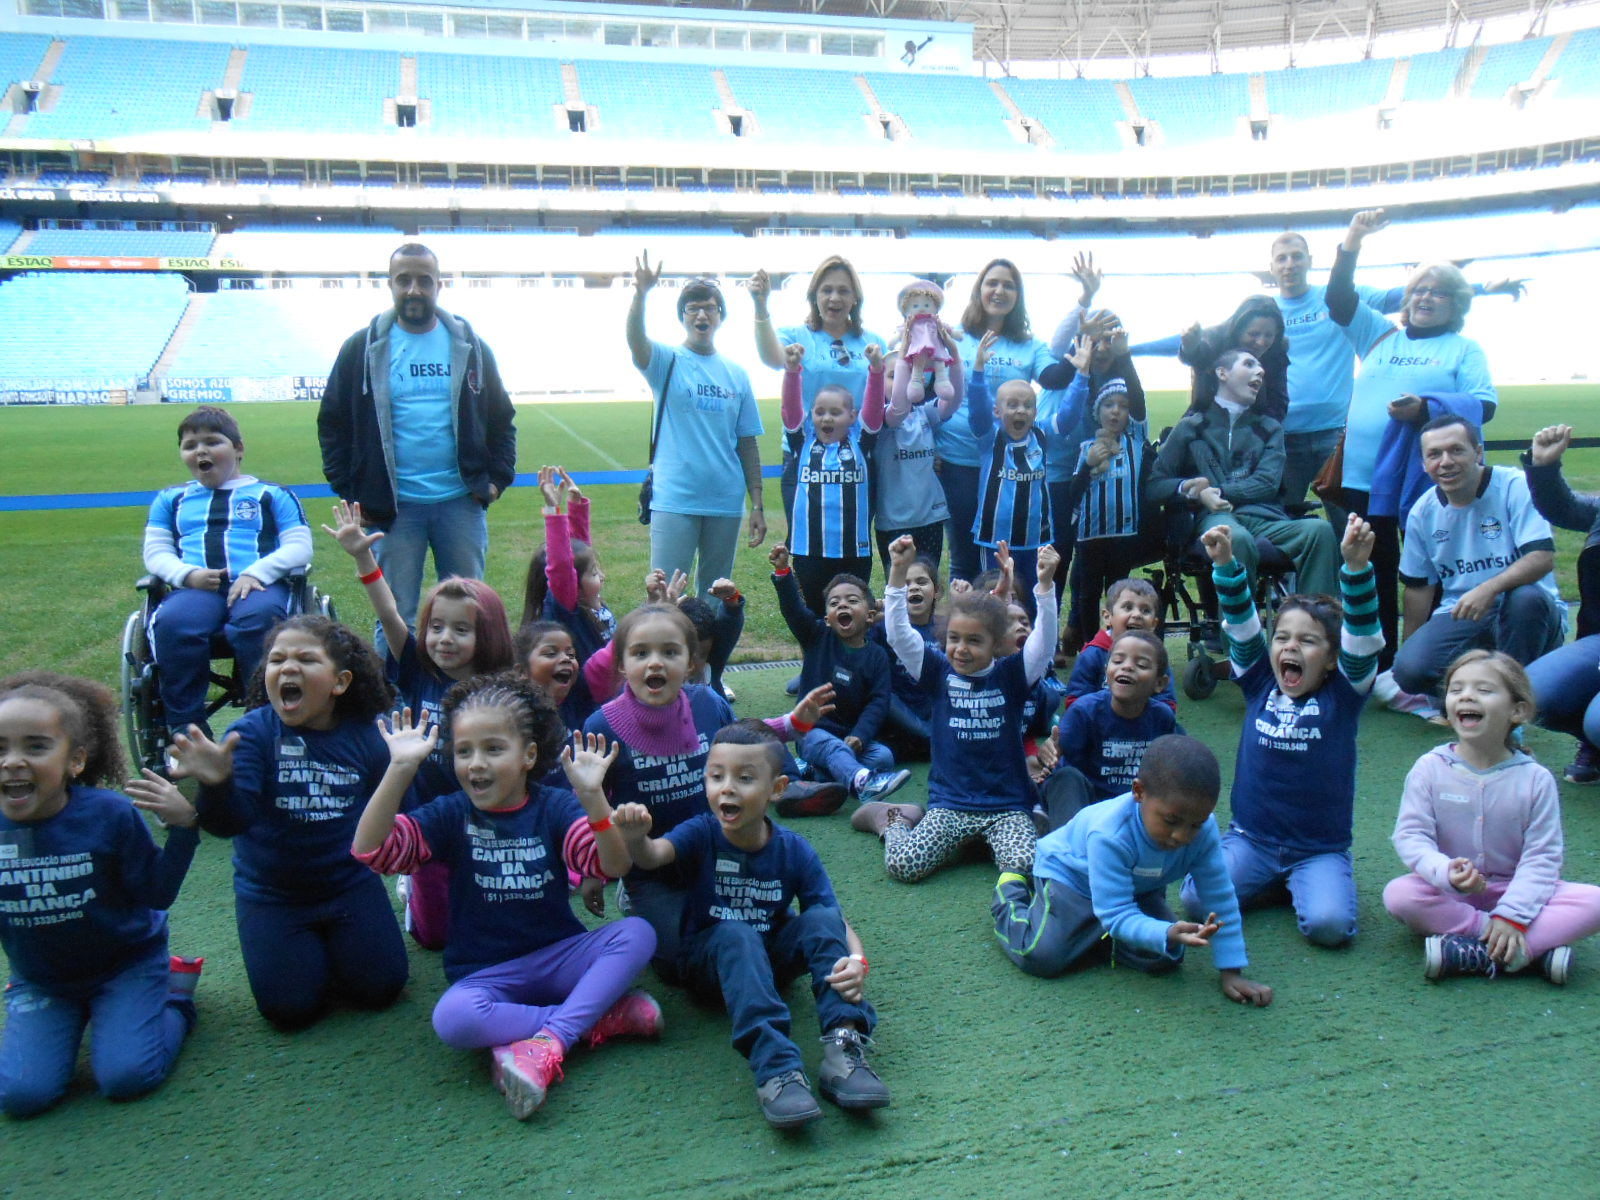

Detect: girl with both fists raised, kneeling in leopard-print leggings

[850,536,1058,883]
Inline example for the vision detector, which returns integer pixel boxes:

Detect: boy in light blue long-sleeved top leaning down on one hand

[990,734,1272,1006]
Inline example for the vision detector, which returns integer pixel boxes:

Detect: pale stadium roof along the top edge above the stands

[614,0,1590,64]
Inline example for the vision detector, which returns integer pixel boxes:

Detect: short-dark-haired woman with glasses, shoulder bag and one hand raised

[627,253,766,597]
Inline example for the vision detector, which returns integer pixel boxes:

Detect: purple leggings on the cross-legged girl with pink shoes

[434,917,656,1050]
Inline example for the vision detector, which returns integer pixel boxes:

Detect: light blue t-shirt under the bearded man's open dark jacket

[389,322,467,504]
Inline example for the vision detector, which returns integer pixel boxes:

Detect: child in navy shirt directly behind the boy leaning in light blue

[1042,629,1182,832]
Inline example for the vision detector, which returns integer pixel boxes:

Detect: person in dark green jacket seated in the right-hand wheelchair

[1146,349,1339,595]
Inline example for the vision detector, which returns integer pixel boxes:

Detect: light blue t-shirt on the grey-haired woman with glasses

[1344,304,1496,491]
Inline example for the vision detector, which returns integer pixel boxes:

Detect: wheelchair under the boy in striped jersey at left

[122,571,336,771]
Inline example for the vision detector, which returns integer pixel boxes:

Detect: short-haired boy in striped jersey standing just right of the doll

[966,330,1054,618]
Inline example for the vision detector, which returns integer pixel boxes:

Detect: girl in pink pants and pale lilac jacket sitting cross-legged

[1384,650,1600,984]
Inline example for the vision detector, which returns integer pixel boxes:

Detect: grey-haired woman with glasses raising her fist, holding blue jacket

[1326,208,1496,669]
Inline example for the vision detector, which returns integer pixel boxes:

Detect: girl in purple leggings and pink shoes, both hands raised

[350,672,662,1120]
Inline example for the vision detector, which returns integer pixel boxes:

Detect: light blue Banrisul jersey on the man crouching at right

[1400,467,1566,613]
